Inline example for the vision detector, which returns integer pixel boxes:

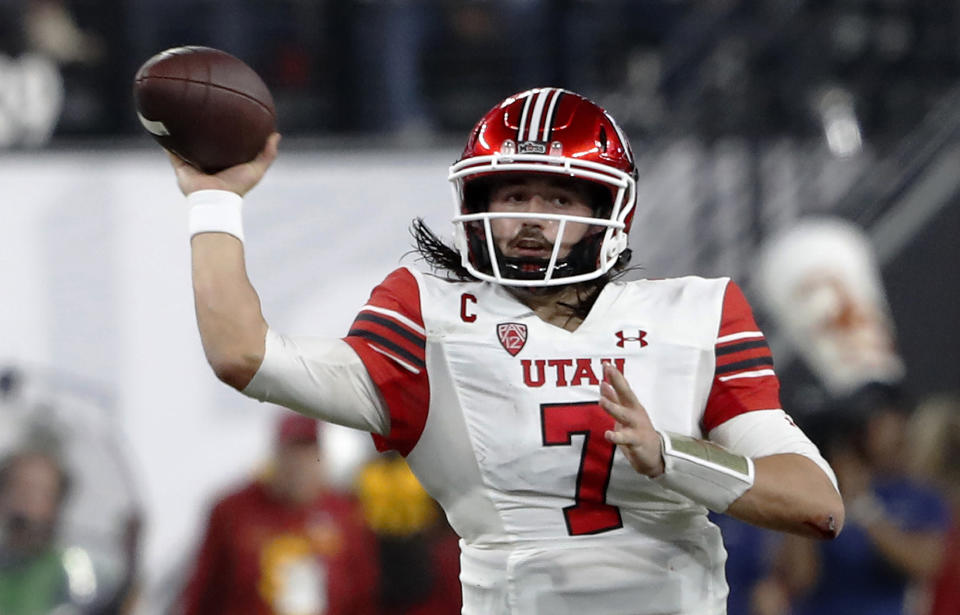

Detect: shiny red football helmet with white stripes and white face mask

[448,88,637,286]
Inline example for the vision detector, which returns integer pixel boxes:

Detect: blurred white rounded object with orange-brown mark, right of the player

[757,218,905,396]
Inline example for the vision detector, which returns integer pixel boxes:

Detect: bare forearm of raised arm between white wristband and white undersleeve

[190,233,267,389]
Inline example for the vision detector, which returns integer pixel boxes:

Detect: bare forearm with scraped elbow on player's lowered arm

[726,453,844,538]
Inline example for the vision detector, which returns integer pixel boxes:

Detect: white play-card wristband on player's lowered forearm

[654,431,754,512]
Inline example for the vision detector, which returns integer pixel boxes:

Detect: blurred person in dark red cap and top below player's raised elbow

[178,411,378,615]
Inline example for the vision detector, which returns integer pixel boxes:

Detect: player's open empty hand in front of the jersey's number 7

[600,363,664,478]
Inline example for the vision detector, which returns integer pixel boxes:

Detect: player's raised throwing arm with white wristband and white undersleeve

[170,134,390,434]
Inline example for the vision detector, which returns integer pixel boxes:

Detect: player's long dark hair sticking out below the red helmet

[410,218,634,319]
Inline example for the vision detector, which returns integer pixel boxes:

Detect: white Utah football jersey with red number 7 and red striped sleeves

[346,268,780,615]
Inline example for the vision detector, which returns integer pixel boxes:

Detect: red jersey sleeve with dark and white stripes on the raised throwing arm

[344,268,430,455]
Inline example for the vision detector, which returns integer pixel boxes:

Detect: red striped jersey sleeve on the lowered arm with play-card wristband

[702,280,780,433]
